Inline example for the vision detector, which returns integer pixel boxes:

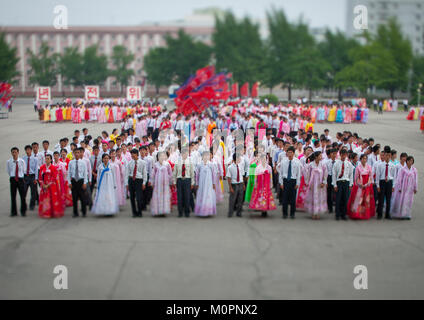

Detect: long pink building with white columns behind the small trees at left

[0,25,213,96]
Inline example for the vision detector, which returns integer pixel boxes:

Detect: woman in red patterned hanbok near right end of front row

[347,154,375,220]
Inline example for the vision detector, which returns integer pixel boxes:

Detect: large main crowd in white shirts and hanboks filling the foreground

[7,105,418,220]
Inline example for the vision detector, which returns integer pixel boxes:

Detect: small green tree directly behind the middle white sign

[81,45,110,86]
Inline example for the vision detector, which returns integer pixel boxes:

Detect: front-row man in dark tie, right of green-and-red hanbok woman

[279,146,302,219]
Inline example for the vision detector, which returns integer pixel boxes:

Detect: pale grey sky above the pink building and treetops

[0,0,346,30]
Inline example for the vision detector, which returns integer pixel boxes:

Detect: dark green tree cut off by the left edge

[0,33,19,84]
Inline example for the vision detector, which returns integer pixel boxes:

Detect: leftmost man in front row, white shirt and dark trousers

[6,147,27,217]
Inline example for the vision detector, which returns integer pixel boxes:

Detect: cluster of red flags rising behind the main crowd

[174,66,231,115]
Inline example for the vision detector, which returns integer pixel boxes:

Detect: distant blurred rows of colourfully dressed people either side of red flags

[34,99,369,125]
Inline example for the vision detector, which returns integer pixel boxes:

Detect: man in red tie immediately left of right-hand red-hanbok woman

[332,149,353,220]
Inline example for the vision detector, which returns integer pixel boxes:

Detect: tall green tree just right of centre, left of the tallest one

[212,11,264,85]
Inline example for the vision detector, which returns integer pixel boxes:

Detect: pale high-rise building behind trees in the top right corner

[346,0,424,55]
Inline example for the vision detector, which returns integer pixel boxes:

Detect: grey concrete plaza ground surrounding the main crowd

[0,102,424,299]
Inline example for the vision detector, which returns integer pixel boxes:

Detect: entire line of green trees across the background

[0,8,424,100]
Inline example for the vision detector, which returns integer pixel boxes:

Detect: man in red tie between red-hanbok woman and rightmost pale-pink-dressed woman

[375,146,396,219]
